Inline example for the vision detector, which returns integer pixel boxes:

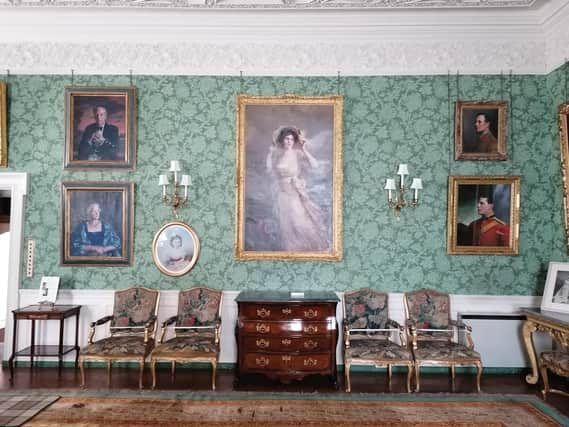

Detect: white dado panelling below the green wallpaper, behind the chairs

[11,290,541,366]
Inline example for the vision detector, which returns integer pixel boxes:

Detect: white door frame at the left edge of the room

[0,172,28,360]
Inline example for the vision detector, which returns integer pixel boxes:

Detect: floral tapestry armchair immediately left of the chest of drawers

[150,287,222,390]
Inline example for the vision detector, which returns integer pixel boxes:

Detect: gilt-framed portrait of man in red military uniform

[447,176,520,255]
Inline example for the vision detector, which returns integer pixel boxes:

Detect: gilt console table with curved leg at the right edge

[522,308,569,384]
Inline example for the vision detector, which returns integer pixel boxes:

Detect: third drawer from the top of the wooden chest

[243,334,334,353]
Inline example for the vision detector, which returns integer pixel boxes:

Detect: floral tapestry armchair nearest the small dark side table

[79,286,160,388]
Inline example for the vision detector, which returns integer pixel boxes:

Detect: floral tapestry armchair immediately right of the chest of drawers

[344,288,413,392]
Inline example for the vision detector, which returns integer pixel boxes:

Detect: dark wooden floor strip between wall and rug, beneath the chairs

[0,367,569,416]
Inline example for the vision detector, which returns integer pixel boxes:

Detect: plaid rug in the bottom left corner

[0,393,59,427]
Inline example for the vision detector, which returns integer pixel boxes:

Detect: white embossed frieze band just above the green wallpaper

[0,40,545,76]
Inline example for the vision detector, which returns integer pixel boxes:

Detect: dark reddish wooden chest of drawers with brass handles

[236,291,338,384]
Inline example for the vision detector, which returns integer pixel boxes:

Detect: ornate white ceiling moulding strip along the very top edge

[0,0,539,9]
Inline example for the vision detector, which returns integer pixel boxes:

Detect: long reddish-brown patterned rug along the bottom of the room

[25,393,569,427]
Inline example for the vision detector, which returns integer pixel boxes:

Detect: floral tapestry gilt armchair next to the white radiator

[405,289,482,392]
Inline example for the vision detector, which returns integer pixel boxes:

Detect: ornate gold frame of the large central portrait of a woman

[234,95,344,261]
